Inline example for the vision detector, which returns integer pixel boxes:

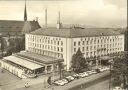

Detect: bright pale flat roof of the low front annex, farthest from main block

[4,55,43,70]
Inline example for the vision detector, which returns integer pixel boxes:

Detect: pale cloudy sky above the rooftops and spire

[0,0,127,27]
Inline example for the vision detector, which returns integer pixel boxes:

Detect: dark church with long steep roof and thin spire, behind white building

[0,3,40,56]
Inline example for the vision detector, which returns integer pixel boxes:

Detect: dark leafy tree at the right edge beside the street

[112,53,128,87]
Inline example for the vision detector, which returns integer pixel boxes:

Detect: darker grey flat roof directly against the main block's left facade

[17,51,64,64]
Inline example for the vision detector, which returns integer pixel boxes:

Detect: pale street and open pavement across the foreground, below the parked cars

[0,66,109,90]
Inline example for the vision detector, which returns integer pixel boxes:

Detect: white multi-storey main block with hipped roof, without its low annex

[25,28,124,70]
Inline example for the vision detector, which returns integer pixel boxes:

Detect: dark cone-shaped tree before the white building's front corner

[71,48,88,73]
